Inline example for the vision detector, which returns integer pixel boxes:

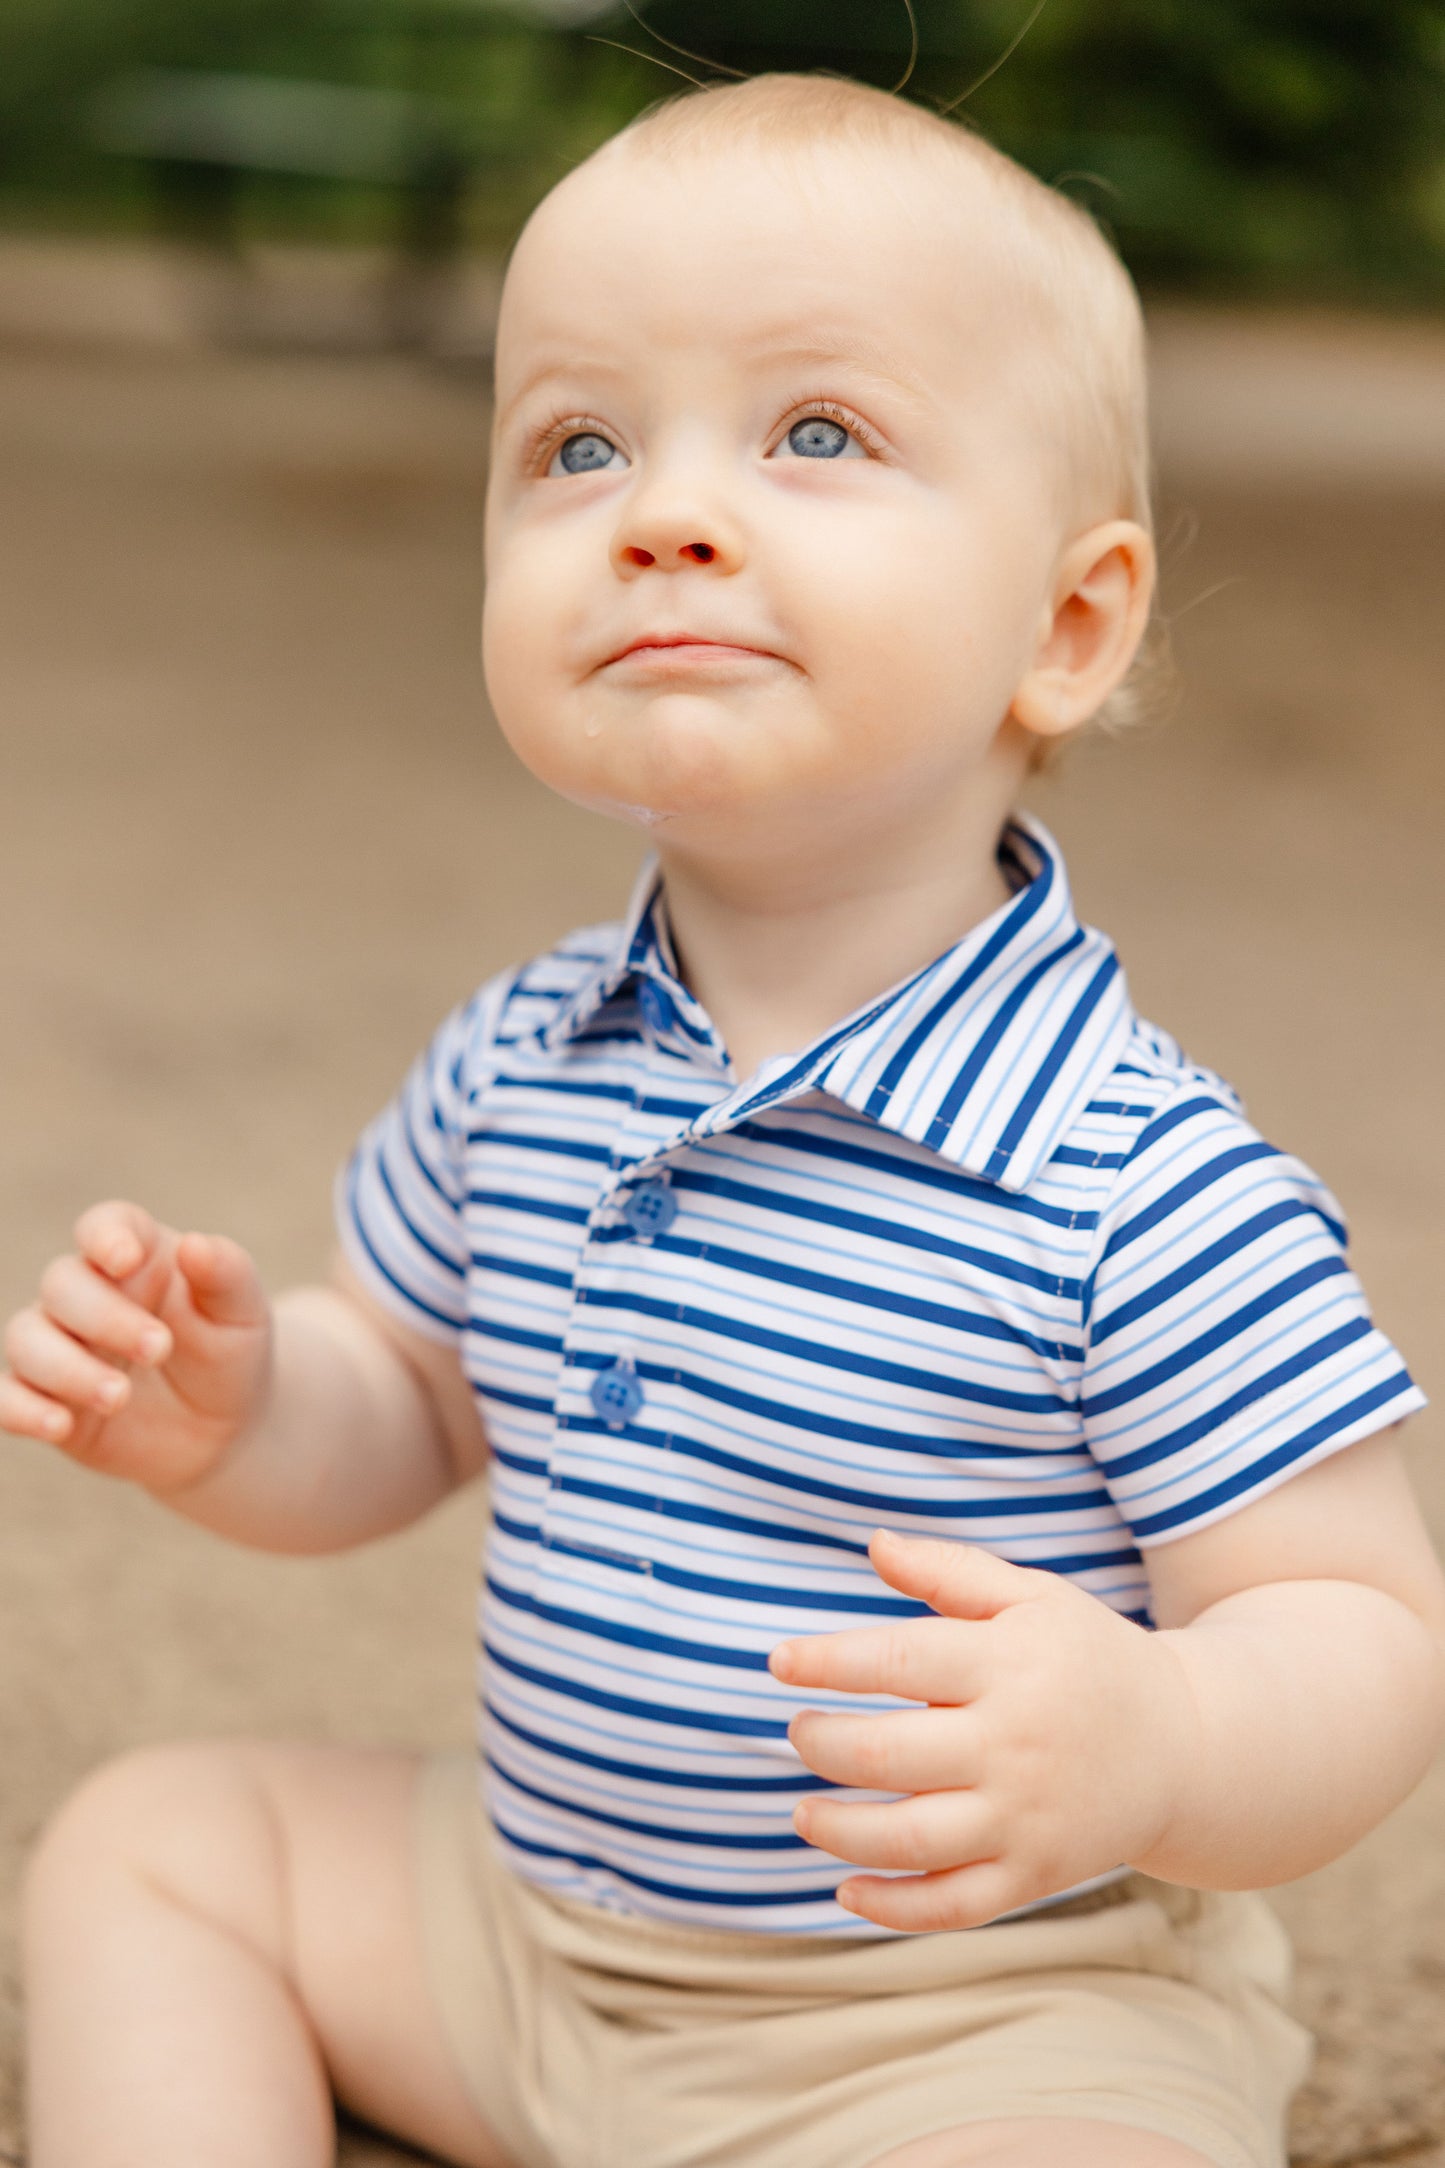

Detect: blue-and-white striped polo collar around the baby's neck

[544,815,1133,1190]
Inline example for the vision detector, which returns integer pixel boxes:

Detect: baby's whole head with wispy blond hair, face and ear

[485,76,1153,888]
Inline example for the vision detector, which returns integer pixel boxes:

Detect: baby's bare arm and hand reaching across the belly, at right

[771,1437,1445,1930]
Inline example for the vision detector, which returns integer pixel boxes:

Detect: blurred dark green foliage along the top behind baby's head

[0,0,1445,304]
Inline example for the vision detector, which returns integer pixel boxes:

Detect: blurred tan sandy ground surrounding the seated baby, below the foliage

[0,271,1445,2168]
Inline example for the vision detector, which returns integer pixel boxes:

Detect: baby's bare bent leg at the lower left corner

[24,1741,507,2168]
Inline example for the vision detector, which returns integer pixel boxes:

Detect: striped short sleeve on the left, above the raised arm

[336,986,500,1342]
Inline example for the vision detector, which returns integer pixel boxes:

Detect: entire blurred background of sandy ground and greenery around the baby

[0,0,1445,2168]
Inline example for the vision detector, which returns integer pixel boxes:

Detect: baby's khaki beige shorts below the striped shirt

[418,1756,1309,2168]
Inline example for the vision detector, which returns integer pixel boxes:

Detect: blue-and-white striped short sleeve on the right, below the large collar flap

[1081,1084,1423,1548]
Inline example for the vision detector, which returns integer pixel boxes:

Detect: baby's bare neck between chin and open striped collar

[661,789,1010,1080]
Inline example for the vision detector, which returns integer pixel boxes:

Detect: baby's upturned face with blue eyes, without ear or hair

[483,150,1066,852]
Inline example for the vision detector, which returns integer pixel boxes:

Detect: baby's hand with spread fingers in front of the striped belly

[769,1533,1198,1932]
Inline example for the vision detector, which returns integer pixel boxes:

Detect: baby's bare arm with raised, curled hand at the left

[0,1203,485,1552]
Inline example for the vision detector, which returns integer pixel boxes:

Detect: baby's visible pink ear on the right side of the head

[1010,520,1155,737]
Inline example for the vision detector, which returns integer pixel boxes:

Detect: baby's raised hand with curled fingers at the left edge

[0,1203,271,1492]
